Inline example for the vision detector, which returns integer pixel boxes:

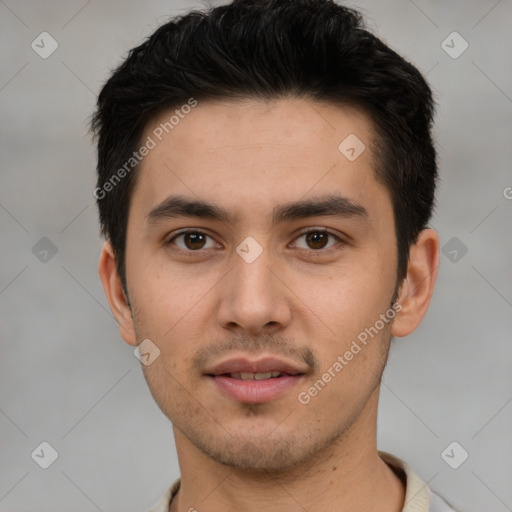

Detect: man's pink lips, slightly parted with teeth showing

[206,358,306,404]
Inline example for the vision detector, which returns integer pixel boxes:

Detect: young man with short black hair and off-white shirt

[93,0,453,512]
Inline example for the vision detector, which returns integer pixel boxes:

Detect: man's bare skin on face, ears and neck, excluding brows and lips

[99,98,439,512]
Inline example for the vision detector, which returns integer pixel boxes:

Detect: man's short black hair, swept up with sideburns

[92,0,437,292]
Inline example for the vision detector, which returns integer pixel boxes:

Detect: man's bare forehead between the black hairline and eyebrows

[132,98,389,223]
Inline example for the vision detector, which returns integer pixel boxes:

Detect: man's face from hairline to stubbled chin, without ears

[122,99,397,469]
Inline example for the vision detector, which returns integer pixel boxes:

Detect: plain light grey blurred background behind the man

[0,0,512,512]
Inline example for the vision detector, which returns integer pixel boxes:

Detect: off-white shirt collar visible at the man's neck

[149,452,456,512]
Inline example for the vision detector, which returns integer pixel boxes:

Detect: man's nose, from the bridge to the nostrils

[217,250,292,336]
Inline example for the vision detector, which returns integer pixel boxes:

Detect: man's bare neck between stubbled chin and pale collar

[170,389,405,512]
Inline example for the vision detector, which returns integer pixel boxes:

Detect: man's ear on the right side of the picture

[391,229,439,337]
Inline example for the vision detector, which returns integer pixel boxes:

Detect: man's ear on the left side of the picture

[98,242,137,346]
